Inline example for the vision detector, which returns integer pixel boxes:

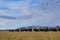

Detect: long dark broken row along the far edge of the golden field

[9,26,60,32]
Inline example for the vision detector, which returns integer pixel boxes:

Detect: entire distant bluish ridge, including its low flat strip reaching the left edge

[0,26,60,31]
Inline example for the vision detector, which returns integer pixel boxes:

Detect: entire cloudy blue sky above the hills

[0,0,60,30]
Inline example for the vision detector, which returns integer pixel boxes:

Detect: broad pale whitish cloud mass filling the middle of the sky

[0,0,60,28]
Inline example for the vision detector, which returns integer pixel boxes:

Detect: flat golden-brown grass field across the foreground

[0,32,60,40]
